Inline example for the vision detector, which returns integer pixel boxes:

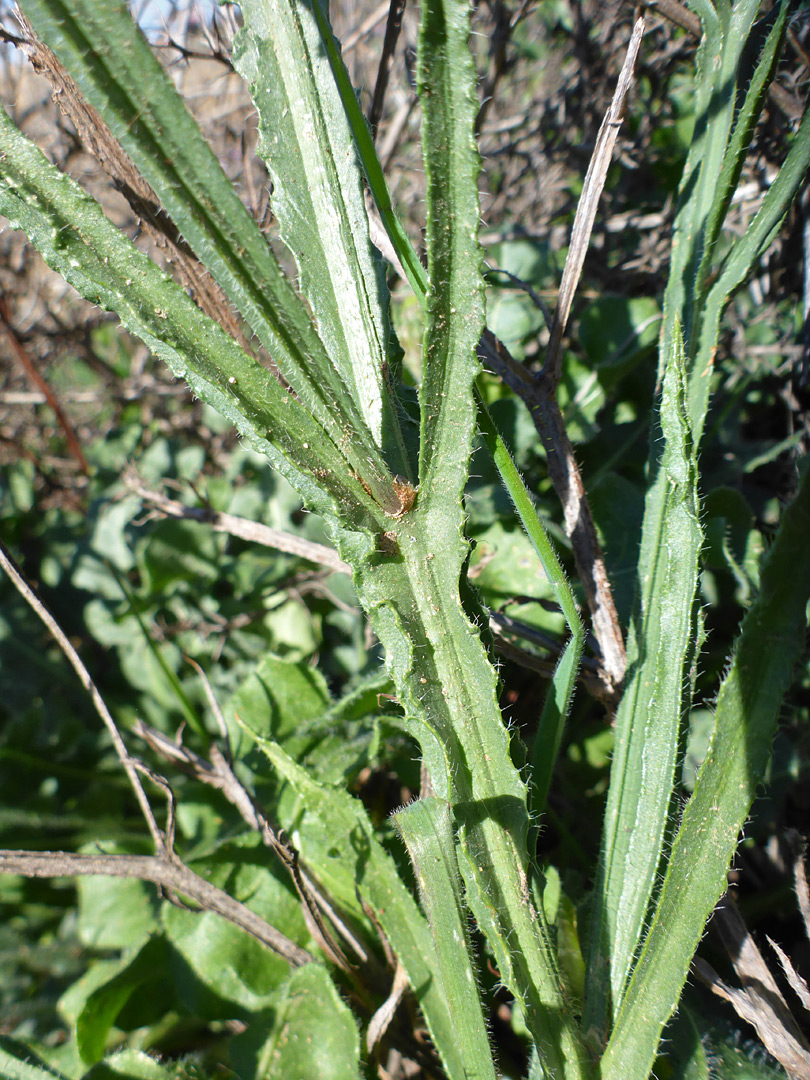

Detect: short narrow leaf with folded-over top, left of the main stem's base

[394,798,495,1080]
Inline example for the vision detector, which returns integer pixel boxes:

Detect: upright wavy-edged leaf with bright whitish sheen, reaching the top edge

[233,0,414,480]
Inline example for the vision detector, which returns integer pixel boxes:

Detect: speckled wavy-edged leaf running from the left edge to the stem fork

[0,103,384,527]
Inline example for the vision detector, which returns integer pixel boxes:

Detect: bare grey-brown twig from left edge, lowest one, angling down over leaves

[0,851,313,968]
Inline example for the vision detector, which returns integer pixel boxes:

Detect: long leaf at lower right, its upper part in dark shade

[602,460,810,1080]
